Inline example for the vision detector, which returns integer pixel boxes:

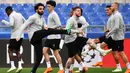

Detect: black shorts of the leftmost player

[8,38,23,51]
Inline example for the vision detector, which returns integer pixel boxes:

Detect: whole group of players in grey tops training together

[2,1,130,73]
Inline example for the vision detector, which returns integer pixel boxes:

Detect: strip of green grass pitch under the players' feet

[0,68,126,73]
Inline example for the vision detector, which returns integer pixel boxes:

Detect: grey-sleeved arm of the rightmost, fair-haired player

[106,15,120,36]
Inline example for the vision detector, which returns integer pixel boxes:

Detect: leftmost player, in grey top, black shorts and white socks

[2,6,25,73]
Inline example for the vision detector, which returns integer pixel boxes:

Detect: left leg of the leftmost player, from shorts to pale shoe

[7,39,16,72]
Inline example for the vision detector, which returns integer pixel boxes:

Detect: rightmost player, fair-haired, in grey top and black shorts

[106,2,130,73]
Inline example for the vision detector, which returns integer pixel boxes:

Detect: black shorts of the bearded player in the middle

[66,37,88,58]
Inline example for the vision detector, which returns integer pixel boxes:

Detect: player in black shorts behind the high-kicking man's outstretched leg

[43,1,64,73]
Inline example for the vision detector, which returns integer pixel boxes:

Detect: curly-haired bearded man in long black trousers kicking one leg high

[16,3,70,73]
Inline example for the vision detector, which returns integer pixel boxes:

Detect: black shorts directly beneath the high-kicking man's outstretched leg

[44,39,61,50]
